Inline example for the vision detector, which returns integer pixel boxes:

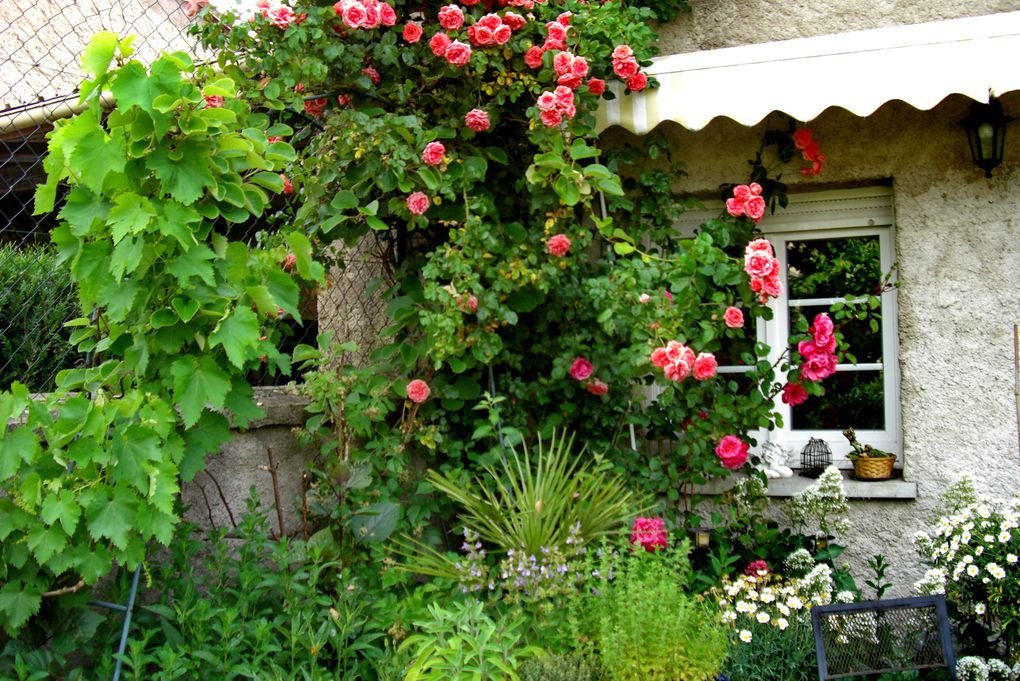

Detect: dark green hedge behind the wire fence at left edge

[0,245,79,392]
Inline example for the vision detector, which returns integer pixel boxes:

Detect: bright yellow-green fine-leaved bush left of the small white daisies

[571,541,727,681]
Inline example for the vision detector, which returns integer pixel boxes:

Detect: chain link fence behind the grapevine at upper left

[0,0,386,391]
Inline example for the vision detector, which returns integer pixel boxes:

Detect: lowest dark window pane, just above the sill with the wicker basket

[791,371,885,430]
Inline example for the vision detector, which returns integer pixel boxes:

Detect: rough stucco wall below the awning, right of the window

[604,93,1020,592]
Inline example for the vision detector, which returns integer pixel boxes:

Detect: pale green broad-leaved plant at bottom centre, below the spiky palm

[400,600,539,681]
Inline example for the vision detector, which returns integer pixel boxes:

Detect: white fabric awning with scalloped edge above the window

[599,11,1020,134]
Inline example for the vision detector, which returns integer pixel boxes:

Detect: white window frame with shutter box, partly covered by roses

[676,186,903,468]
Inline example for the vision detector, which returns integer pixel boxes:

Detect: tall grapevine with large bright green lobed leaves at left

[0,34,314,633]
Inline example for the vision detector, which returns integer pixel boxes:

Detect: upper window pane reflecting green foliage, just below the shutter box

[786,235,882,300]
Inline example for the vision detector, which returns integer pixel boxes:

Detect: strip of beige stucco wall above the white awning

[659,0,1020,54]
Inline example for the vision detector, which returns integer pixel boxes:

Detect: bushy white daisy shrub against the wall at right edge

[915,481,1020,660]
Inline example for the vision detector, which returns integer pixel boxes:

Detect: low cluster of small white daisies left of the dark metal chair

[714,564,832,643]
